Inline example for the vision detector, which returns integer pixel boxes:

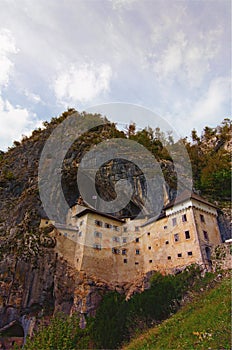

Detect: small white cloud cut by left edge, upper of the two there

[0,28,18,88]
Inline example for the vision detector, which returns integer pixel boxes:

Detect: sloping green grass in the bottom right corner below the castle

[124,276,231,350]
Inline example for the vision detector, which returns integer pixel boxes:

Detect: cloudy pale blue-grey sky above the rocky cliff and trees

[0,0,231,150]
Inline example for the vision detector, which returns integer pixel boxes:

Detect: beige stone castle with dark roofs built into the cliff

[41,191,221,283]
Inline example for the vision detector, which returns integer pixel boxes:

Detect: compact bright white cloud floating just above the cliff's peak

[54,64,112,105]
